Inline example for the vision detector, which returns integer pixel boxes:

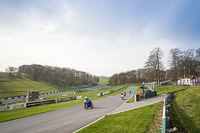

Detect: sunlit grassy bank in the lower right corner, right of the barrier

[170,87,200,133]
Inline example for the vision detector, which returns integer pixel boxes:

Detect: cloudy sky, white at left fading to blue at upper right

[0,0,200,76]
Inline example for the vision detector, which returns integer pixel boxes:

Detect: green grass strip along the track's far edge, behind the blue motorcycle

[0,84,136,122]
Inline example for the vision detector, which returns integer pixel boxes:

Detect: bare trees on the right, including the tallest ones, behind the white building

[109,48,200,85]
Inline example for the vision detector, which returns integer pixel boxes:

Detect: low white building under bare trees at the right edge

[177,78,200,86]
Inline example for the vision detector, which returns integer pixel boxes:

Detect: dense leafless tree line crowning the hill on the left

[7,64,99,86]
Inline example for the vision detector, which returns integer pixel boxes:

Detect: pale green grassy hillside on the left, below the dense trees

[0,72,79,98]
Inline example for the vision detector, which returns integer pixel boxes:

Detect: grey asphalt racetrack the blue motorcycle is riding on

[0,87,136,133]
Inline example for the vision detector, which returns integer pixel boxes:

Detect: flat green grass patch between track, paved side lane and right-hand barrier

[79,102,162,133]
